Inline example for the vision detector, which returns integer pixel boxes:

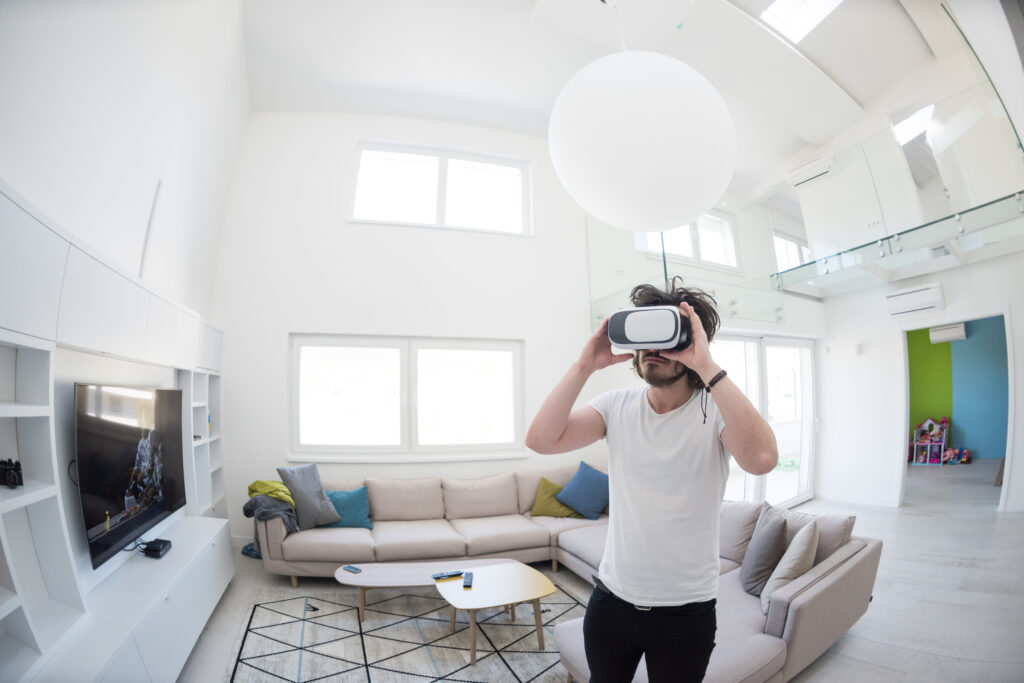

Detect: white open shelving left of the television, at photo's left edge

[0,330,85,681]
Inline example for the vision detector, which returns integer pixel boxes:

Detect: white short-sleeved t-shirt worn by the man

[590,387,730,606]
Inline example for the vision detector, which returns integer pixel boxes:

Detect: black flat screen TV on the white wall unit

[75,384,185,568]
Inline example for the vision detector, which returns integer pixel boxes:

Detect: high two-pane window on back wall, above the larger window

[351,145,529,234]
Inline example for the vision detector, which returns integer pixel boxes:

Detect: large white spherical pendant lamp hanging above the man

[548,51,736,232]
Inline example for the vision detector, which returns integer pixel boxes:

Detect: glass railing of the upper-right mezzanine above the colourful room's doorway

[772,81,1024,295]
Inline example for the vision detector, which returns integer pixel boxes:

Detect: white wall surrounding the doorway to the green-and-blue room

[815,254,1024,510]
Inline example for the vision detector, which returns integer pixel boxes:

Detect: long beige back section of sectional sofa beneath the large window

[256,465,607,586]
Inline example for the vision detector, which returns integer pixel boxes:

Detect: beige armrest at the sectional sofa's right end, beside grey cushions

[765,538,882,680]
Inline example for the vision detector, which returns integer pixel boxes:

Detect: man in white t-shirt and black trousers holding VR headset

[526,279,778,683]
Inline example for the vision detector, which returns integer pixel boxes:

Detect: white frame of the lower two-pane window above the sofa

[288,333,525,463]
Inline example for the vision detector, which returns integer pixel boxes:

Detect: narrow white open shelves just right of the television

[178,370,227,517]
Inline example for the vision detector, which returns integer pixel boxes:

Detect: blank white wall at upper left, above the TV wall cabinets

[0,0,249,315]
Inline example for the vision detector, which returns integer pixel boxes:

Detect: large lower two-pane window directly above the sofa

[291,335,522,454]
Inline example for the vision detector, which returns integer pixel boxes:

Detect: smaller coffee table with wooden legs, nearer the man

[436,560,555,665]
